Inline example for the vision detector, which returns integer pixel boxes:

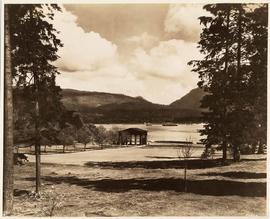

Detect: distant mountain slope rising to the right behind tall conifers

[169,88,205,110]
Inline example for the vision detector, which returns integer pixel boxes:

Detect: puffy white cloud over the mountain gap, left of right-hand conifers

[130,40,199,82]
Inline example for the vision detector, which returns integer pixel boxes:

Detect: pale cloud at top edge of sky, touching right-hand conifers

[164,4,208,41]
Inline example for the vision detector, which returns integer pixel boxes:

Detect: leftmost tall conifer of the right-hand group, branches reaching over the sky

[189,4,235,161]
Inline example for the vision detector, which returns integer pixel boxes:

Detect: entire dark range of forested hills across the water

[62,88,206,123]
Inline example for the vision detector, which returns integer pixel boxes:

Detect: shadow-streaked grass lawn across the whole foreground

[14,146,266,216]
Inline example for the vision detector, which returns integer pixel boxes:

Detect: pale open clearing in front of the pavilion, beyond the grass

[25,146,213,165]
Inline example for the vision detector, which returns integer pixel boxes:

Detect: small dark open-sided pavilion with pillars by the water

[118,128,147,145]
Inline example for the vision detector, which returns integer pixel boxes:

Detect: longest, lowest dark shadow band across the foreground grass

[25,176,266,197]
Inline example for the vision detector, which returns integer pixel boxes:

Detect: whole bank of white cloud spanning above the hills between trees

[54,5,202,104]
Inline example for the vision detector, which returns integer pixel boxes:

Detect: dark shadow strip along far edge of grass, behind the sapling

[85,159,229,169]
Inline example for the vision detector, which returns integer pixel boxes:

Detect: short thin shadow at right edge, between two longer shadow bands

[198,171,266,179]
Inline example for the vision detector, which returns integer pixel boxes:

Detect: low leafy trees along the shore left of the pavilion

[14,109,118,152]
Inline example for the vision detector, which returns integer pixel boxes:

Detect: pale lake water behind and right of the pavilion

[97,123,203,143]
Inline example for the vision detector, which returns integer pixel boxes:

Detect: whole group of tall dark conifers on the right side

[189,4,268,161]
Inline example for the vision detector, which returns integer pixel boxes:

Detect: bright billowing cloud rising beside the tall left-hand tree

[54,8,118,72]
